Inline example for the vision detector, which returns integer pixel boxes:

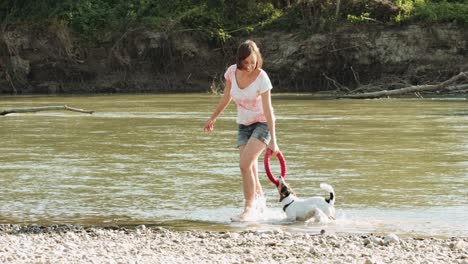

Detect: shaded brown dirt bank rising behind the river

[0,24,468,94]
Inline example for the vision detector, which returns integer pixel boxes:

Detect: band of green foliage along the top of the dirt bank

[0,0,468,43]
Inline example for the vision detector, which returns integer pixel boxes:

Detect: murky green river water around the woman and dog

[0,94,468,236]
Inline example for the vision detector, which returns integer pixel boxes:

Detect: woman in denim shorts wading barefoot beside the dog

[204,40,279,221]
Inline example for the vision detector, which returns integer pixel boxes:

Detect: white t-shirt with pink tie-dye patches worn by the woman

[224,64,274,125]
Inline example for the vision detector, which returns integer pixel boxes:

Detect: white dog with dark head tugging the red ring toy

[278,177,336,222]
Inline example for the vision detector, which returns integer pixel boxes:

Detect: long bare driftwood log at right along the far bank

[339,72,468,99]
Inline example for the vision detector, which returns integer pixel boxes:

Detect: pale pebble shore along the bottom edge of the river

[0,225,468,264]
